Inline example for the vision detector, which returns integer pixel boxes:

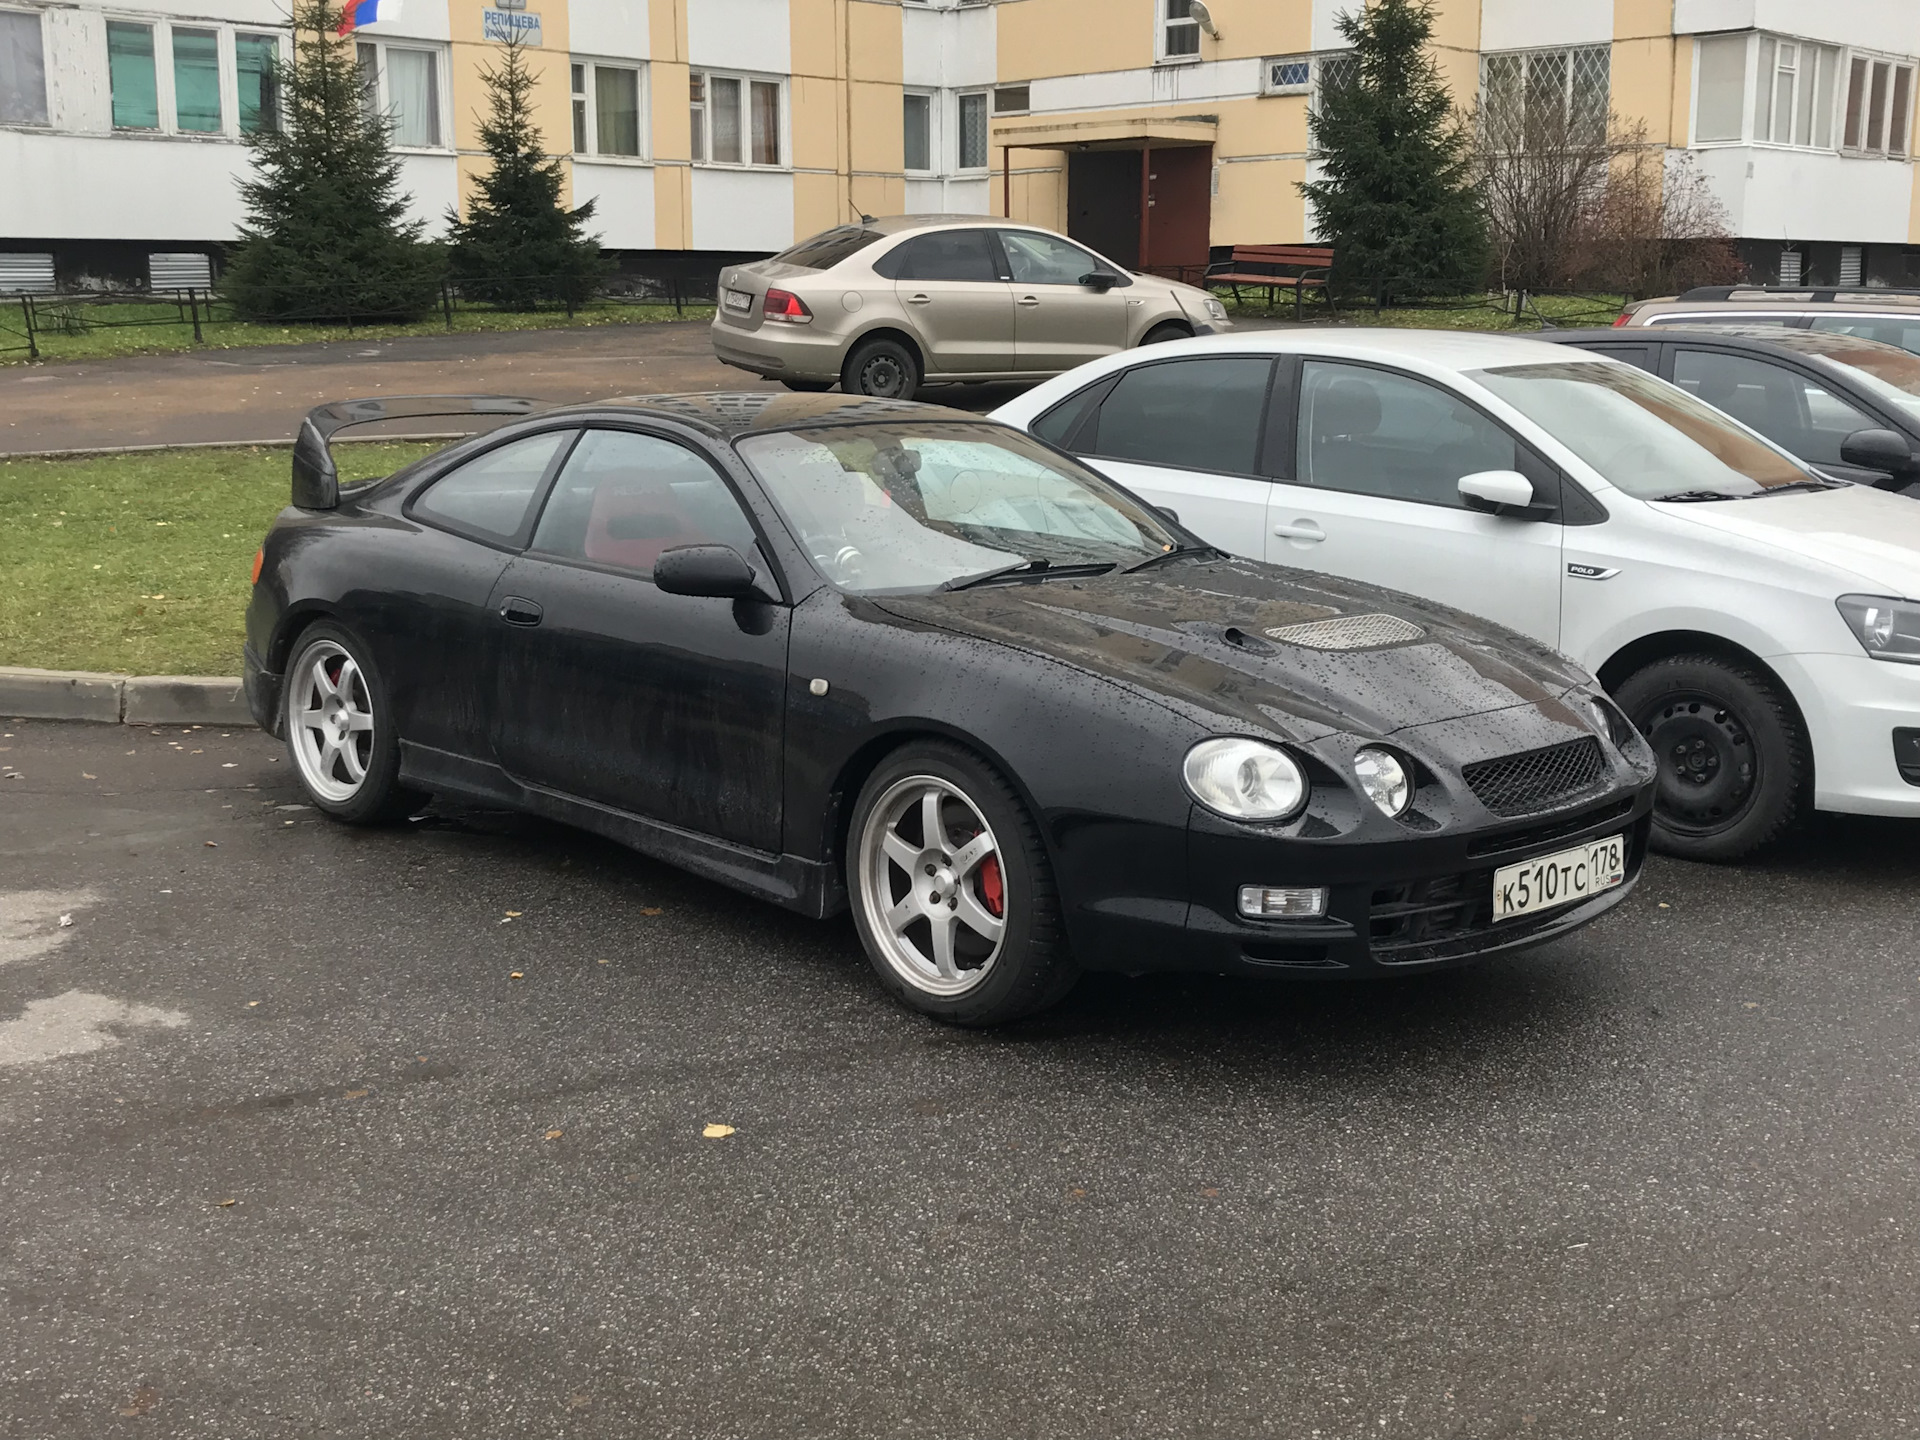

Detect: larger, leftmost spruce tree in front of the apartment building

[221,0,445,321]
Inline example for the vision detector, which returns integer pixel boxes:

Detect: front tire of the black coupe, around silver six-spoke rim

[847,741,1079,1025]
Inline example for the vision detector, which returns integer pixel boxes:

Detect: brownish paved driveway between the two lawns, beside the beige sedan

[0,321,1018,455]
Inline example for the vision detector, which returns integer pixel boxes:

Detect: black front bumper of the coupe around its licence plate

[1073,785,1653,977]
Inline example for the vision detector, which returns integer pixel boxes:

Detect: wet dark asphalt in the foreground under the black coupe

[0,722,1920,1440]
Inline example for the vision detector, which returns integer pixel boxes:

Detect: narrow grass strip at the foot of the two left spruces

[0,301,714,363]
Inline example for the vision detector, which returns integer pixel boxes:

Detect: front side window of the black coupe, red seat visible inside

[534,430,755,576]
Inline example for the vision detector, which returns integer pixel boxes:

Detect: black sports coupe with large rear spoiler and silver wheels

[246,394,1653,1025]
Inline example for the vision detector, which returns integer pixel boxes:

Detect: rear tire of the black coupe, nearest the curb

[280,620,424,826]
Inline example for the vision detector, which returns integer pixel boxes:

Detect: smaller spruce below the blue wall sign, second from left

[447,35,611,309]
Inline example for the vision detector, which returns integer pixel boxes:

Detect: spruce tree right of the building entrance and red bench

[1300,0,1486,301]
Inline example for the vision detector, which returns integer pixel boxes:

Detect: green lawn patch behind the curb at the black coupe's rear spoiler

[0,444,436,676]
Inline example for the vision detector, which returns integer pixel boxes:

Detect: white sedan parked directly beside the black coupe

[996,330,1920,860]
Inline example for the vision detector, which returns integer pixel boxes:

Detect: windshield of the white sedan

[1473,361,1818,499]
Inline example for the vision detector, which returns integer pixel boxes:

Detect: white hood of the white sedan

[1661,486,1920,599]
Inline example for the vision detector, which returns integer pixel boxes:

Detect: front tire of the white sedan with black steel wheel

[1615,655,1812,860]
